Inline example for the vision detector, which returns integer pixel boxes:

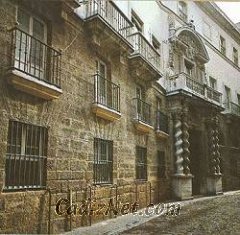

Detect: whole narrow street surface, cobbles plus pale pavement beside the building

[66,191,240,235]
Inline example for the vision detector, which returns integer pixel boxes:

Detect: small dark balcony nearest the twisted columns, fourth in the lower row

[156,110,169,138]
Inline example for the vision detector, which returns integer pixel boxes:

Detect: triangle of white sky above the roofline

[215,1,240,23]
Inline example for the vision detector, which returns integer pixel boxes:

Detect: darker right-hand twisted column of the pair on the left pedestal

[182,108,190,175]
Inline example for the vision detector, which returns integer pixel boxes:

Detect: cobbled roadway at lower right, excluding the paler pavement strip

[122,192,240,235]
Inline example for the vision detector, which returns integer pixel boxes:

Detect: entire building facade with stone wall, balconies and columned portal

[0,0,240,233]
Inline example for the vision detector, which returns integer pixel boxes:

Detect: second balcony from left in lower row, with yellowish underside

[92,74,121,121]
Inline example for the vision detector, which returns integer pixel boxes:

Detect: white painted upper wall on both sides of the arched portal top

[77,0,240,102]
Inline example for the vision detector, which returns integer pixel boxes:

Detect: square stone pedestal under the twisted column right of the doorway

[207,175,223,195]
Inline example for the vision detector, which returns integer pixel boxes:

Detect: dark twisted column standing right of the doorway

[209,117,221,175]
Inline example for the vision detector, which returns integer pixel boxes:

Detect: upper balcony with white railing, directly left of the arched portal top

[128,32,162,80]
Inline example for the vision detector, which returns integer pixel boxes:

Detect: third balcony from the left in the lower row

[134,98,153,133]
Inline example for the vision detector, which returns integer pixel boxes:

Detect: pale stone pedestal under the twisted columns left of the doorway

[172,175,193,200]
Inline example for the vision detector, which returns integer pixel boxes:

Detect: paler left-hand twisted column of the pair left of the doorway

[174,113,183,175]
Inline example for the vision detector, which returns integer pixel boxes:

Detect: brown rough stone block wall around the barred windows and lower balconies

[0,0,171,233]
